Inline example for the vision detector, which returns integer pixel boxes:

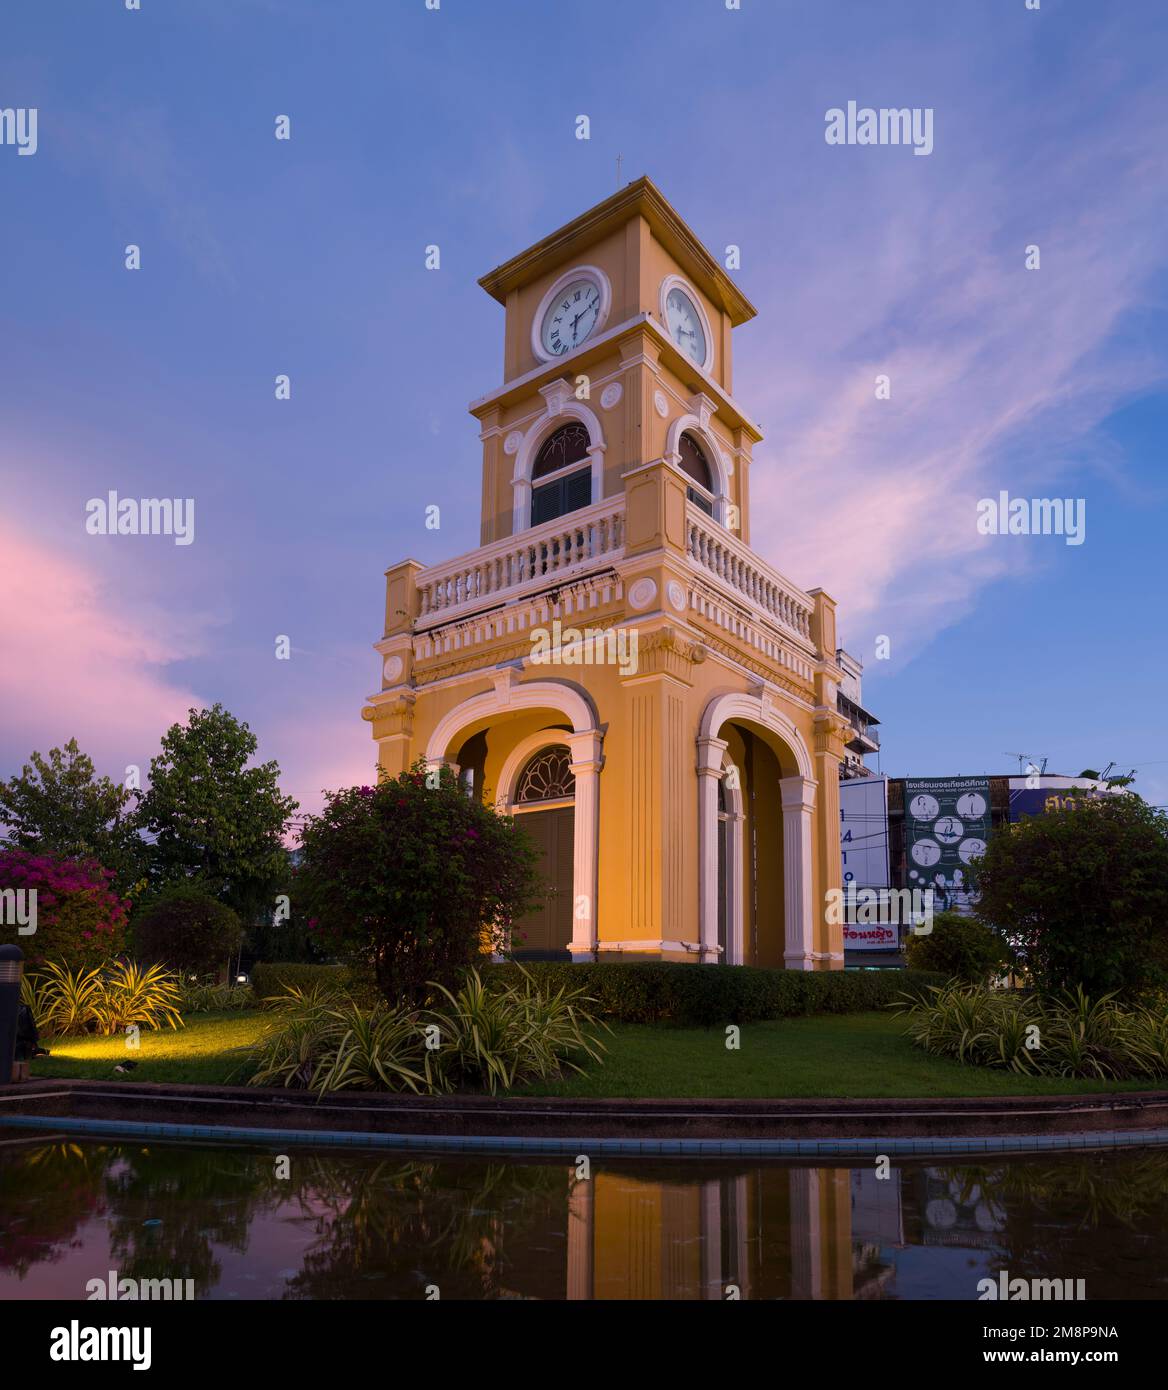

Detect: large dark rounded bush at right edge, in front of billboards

[973,792,1168,997]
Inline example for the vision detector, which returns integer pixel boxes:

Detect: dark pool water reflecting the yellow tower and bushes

[0,1140,1168,1300]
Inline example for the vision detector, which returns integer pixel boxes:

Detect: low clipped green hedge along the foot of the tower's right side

[485,960,946,1026]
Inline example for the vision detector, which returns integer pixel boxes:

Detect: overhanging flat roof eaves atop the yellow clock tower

[478,175,756,328]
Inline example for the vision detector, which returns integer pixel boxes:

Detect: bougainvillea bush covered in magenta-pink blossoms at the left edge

[0,849,129,969]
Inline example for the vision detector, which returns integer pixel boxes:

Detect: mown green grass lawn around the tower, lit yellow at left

[32,1011,1162,1099]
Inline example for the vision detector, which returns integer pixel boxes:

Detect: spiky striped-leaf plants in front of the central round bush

[252,972,603,1095]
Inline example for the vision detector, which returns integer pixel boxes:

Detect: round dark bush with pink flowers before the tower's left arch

[295,766,538,1005]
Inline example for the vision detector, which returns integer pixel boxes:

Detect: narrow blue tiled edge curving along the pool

[0,1115,1168,1159]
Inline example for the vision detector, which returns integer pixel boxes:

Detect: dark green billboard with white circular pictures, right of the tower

[904,777,990,912]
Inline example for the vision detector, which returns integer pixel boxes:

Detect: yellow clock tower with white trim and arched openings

[363,179,845,969]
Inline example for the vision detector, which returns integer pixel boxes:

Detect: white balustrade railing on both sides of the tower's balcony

[414,493,815,653]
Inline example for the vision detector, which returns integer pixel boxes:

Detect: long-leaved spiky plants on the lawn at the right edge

[891,981,1168,1080]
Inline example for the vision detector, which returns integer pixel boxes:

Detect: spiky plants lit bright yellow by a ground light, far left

[21,960,182,1037]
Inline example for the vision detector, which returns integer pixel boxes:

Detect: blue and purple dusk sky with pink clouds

[0,0,1168,810]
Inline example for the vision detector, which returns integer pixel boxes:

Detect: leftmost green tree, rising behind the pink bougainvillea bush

[0,738,146,894]
